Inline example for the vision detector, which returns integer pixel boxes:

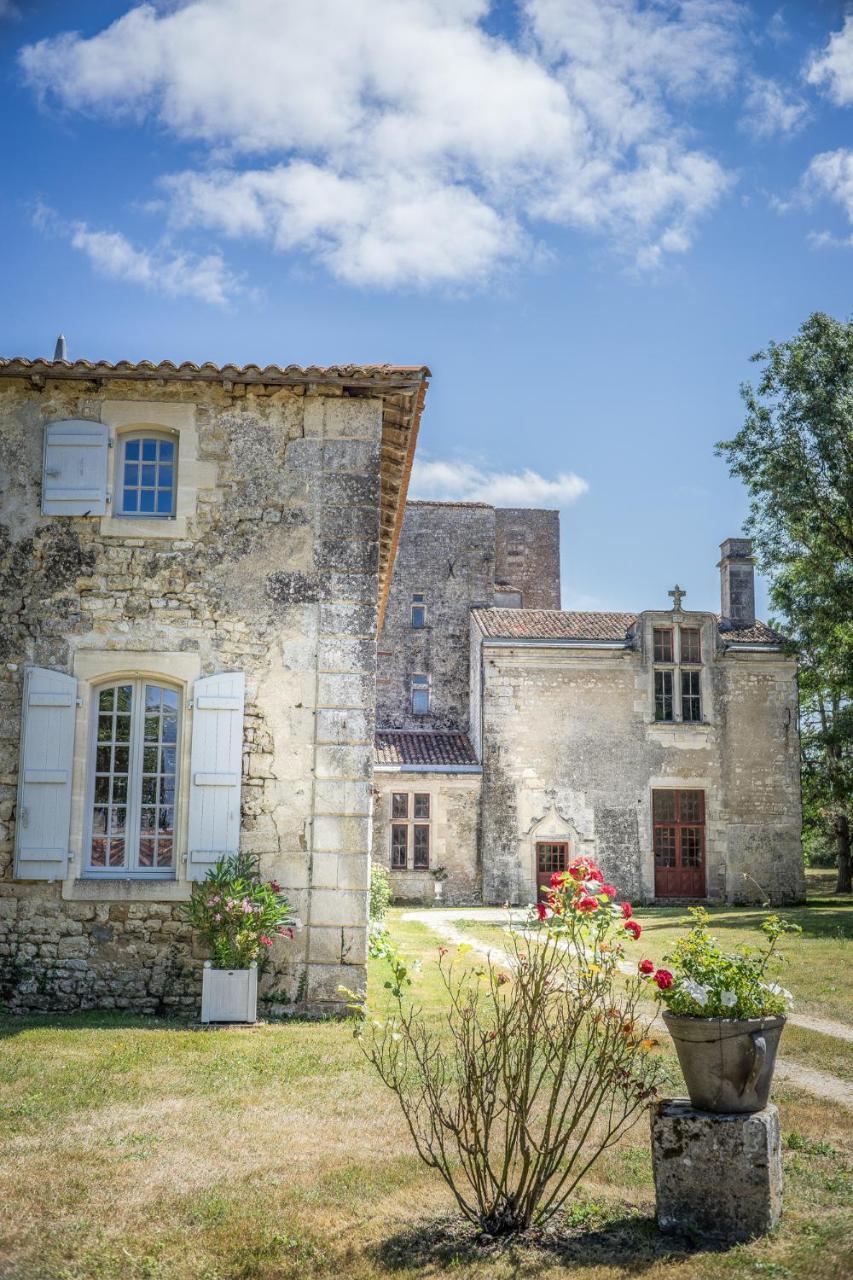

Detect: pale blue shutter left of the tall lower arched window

[15,667,77,879]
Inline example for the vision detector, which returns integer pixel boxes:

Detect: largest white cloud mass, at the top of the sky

[20,0,742,288]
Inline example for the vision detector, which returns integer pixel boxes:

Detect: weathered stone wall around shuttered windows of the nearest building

[0,379,382,1011]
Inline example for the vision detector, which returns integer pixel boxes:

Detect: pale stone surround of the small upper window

[100,399,218,539]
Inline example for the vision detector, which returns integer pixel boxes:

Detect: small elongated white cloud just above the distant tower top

[410,458,589,507]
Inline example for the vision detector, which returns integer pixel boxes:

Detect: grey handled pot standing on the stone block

[663,1010,786,1115]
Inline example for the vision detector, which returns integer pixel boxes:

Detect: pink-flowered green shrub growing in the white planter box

[181,854,296,970]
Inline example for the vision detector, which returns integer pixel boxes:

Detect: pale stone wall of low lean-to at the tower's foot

[373,769,482,906]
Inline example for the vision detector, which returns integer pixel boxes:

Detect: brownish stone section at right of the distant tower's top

[494,507,560,609]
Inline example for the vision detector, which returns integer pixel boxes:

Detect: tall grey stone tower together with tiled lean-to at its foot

[373,502,560,902]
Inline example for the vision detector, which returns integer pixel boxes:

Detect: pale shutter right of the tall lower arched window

[187,671,246,879]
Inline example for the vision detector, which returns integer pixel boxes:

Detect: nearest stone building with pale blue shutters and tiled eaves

[0,350,428,1011]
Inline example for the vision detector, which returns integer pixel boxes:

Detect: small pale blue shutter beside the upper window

[41,419,109,516]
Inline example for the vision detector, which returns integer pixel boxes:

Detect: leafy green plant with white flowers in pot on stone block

[638,906,802,1019]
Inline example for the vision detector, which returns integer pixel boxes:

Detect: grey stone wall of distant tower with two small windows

[377,502,494,730]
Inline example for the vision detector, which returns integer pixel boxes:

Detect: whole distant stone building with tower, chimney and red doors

[373,504,803,904]
